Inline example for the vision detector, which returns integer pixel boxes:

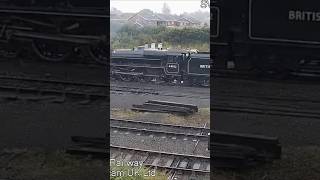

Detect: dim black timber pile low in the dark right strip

[209,131,281,169]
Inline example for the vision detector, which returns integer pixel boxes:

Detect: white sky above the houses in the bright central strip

[110,0,210,15]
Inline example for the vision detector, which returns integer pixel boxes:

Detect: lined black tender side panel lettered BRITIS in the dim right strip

[249,0,320,44]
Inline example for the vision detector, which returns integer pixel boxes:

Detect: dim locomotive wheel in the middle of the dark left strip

[32,40,72,62]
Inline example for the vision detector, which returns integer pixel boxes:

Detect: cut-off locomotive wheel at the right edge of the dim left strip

[88,43,109,64]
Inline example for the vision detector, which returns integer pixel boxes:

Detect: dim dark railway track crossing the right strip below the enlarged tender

[211,92,320,119]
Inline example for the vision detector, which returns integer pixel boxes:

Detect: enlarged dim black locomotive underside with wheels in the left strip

[0,0,109,63]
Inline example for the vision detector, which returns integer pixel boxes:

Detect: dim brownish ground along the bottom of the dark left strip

[0,148,107,180]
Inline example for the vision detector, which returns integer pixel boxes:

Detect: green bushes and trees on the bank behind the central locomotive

[111,25,210,51]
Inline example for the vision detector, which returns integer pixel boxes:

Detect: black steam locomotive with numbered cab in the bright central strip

[110,50,210,87]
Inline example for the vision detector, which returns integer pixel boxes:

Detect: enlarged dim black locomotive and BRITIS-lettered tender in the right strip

[211,0,320,73]
